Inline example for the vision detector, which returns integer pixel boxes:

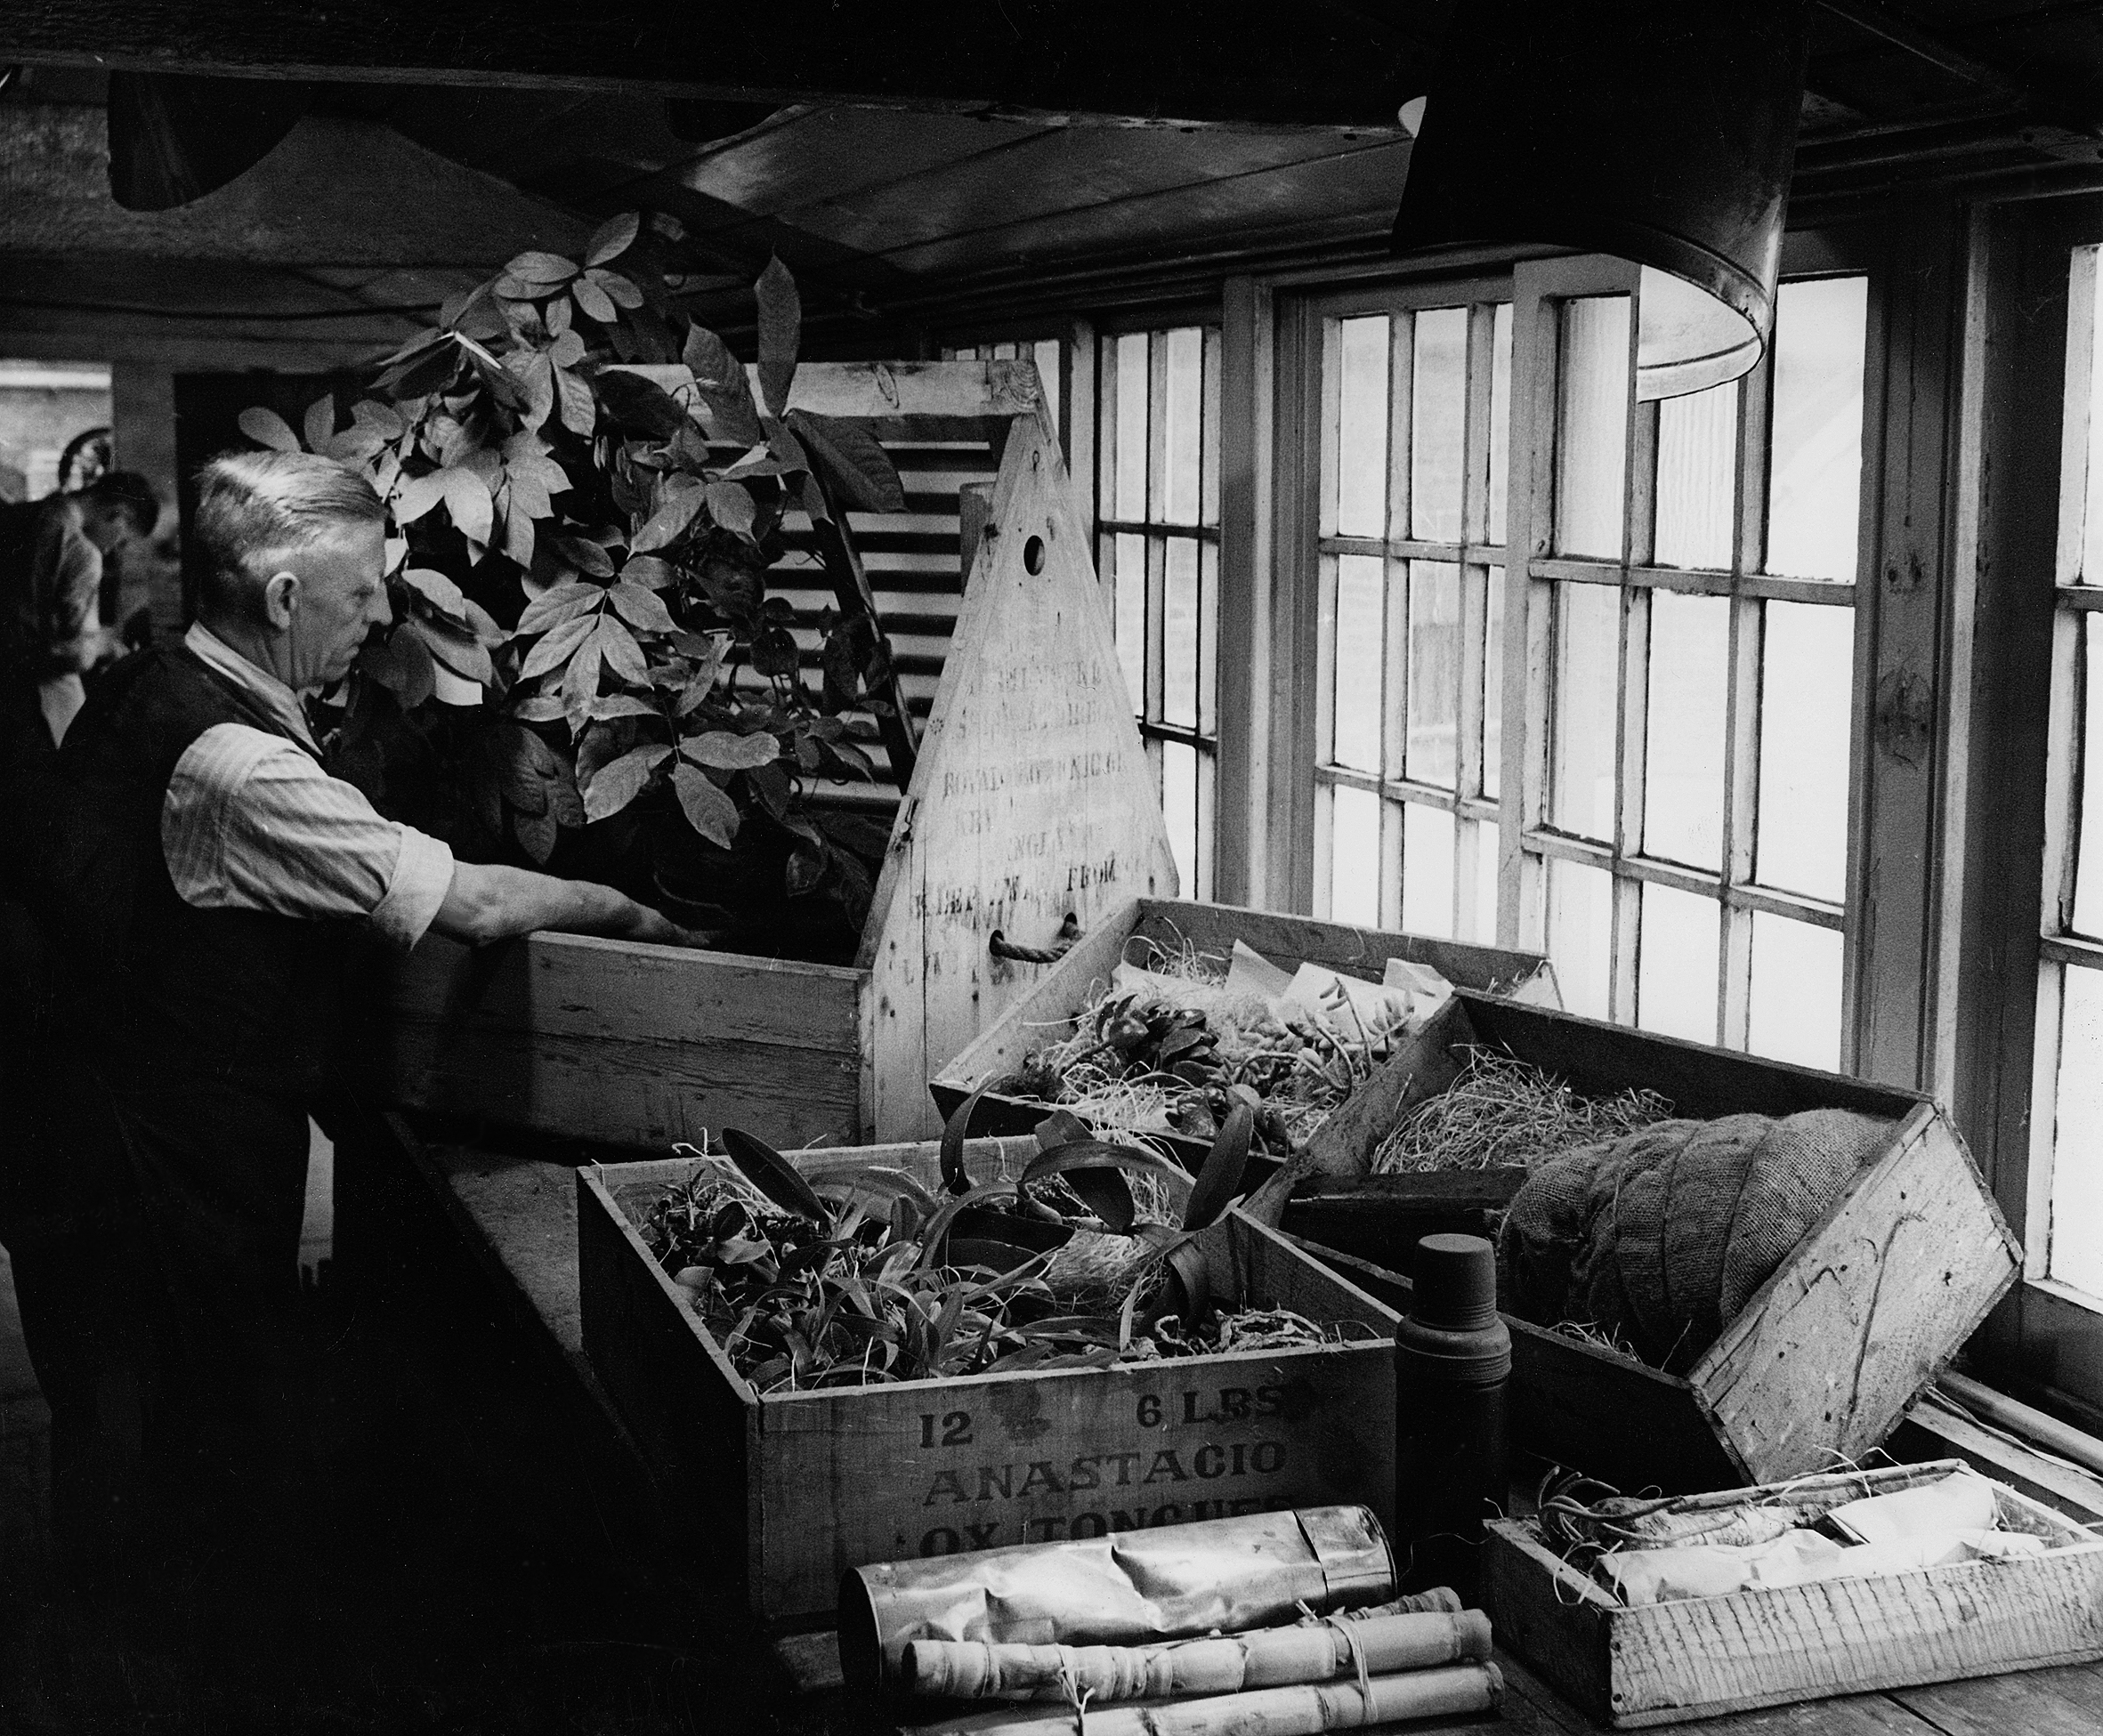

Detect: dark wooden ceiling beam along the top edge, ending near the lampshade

[0,0,1451,133]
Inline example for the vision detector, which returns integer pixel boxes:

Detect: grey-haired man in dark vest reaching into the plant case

[0,452,690,1571]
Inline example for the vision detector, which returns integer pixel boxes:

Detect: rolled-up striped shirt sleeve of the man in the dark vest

[160,723,452,950]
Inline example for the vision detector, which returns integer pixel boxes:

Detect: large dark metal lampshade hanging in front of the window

[1392,0,1811,401]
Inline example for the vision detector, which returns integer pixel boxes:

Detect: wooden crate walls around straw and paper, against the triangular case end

[927,898,1560,1168]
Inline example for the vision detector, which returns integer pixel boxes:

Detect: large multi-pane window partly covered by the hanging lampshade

[1504,265,1867,1068]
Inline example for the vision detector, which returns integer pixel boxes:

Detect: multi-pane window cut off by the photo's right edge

[2026,248,2103,1307]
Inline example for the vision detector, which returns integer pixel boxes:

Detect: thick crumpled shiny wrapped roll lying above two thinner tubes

[839,1507,1395,1688]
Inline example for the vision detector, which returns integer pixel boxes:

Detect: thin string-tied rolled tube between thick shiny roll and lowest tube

[900,1610,1491,1702]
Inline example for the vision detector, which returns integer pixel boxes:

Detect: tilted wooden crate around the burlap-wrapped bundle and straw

[1251,989,2021,1490]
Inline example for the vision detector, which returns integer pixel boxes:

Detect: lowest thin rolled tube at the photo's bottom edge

[917,1665,1504,1736]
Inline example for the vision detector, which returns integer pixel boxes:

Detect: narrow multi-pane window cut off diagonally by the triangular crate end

[1096,326,1220,898]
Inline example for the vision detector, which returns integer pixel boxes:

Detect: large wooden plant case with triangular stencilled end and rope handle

[368,361,1176,1148]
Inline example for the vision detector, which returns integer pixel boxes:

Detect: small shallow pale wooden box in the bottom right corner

[1483,1461,2103,1736]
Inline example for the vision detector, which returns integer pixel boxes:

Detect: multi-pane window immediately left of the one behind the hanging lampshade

[1314,298,1512,941]
